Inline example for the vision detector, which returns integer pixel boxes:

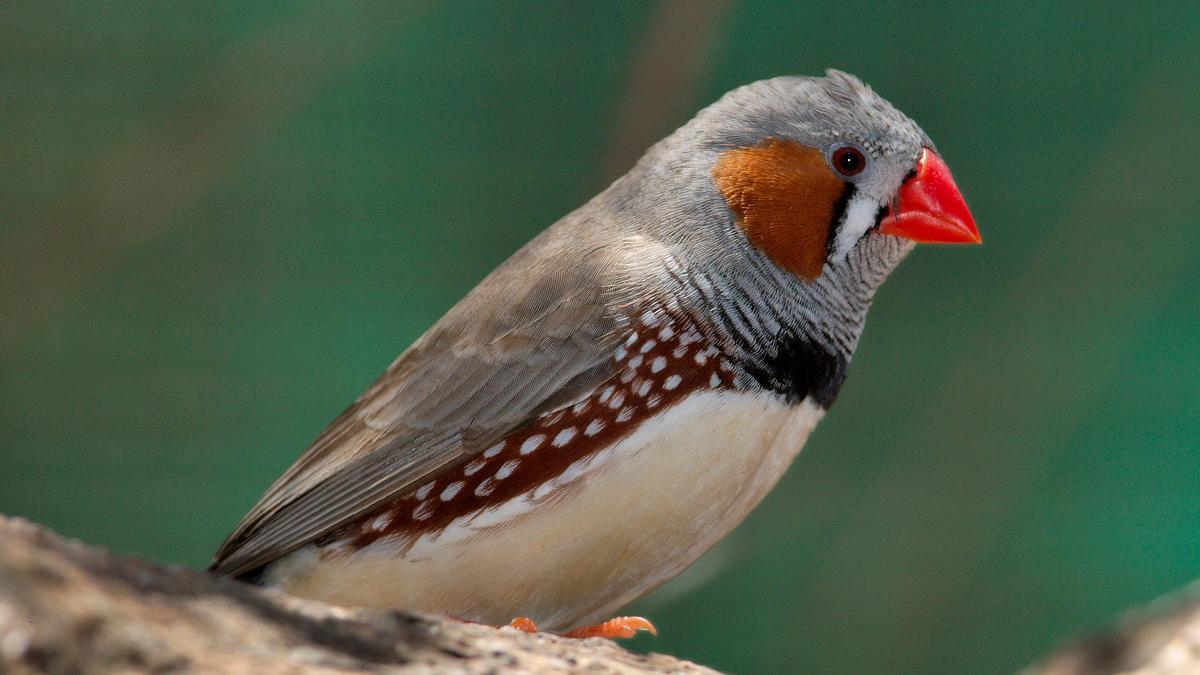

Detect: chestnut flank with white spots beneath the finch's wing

[333,312,734,555]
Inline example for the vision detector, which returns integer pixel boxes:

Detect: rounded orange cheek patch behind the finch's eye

[713,138,846,281]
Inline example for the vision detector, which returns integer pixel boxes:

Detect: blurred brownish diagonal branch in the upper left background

[0,1,432,352]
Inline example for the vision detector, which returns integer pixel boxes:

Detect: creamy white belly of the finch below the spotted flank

[265,390,823,631]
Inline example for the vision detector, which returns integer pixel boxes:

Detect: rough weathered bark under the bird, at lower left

[0,516,713,674]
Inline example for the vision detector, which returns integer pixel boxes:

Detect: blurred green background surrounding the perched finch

[0,0,1200,673]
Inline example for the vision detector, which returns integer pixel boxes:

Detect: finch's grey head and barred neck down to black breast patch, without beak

[596,70,932,406]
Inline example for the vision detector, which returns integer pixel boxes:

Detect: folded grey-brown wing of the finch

[211,229,617,575]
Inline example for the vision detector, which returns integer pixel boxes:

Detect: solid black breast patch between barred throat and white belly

[738,335,850,410]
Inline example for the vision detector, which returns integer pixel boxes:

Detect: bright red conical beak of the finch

[880,148,983,244]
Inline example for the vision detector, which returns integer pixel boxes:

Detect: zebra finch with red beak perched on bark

[210,70,982,637]
